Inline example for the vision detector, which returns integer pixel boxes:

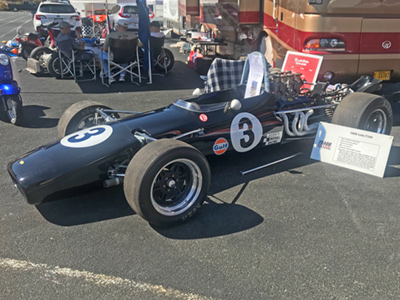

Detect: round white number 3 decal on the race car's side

[231,113,263,152]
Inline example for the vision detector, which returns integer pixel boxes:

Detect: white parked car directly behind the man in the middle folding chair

[109,3,154,30]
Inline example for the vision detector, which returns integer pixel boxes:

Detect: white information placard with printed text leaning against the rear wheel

[311,122,393,178]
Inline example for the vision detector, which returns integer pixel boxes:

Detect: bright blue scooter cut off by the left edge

[0,49,23,125]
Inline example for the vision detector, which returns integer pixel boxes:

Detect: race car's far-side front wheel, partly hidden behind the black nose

[57,100,119,139]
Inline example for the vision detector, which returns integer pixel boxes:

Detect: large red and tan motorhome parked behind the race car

[199,0,400,82]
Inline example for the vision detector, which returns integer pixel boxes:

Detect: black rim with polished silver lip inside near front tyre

[150,159,203,216]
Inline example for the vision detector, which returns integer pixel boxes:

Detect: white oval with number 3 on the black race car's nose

[60,125,113,148]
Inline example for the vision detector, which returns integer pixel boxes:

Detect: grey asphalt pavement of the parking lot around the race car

[0,12,400,300]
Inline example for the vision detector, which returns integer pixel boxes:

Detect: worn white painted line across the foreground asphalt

[0,258,219,300]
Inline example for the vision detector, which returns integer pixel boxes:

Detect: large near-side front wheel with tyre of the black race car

[124,139,211,226]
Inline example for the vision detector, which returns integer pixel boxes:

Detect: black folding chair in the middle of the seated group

[101,38,142,86]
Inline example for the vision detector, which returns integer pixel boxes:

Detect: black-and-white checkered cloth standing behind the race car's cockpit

[204,58,245,93]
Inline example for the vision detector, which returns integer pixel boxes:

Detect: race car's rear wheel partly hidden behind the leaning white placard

[332,93,393,134]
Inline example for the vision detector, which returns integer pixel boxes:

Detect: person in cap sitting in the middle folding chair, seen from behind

[99,19,141,83]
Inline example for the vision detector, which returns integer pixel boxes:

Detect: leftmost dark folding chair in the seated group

[57,41,96,82]
